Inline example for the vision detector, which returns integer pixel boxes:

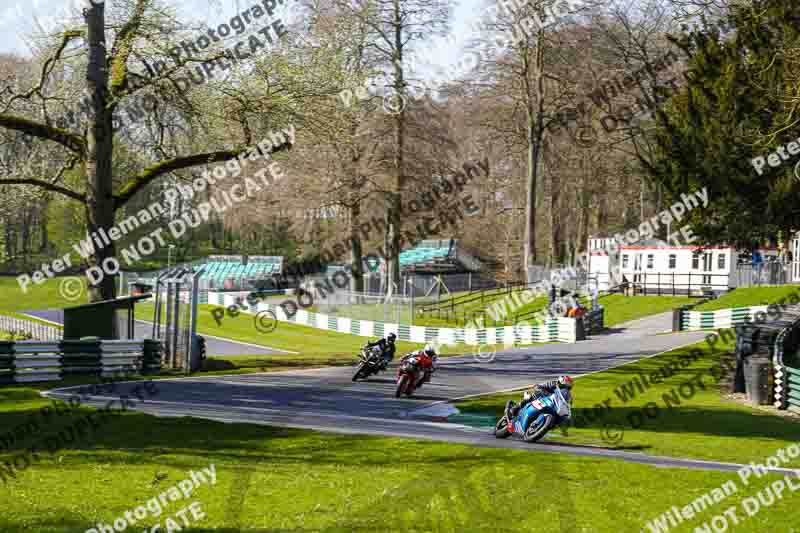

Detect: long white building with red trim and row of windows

[589,235,780,294]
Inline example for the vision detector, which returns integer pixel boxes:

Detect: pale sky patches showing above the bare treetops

[0,0,485,71]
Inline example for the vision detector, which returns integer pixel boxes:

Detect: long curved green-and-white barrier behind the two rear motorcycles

[209,293,582,345]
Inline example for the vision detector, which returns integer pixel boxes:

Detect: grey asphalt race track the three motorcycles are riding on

[46,313,792,473]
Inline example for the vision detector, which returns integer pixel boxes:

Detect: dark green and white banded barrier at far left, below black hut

[0,340,161,384]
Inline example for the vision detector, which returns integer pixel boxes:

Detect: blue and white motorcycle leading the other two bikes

[494,388,572,442]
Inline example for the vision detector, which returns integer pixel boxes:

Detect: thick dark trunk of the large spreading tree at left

[84,3,118,308]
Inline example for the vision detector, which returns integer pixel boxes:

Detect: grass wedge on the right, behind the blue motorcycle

[456,332,800,467]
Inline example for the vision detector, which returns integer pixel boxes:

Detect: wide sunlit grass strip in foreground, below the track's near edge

[0,380,800,533]
